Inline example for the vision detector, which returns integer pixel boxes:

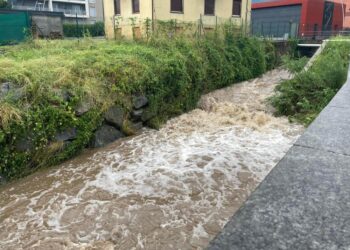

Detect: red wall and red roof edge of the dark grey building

[252,0,348,37]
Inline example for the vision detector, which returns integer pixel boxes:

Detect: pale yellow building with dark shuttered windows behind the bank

[104,0,251,39]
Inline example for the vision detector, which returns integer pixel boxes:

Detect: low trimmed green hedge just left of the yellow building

[63,22,105,37]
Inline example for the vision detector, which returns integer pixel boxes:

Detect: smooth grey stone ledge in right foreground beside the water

[208,69,350,250]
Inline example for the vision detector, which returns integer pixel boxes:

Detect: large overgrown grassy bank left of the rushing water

[0,33,276,179]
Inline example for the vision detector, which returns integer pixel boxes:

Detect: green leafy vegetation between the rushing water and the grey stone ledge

[272,40,350,125]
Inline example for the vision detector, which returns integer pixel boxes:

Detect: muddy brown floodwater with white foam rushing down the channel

[0,70,303,249]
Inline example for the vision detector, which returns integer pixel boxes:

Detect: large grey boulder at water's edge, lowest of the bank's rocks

[92,125,124,148]
